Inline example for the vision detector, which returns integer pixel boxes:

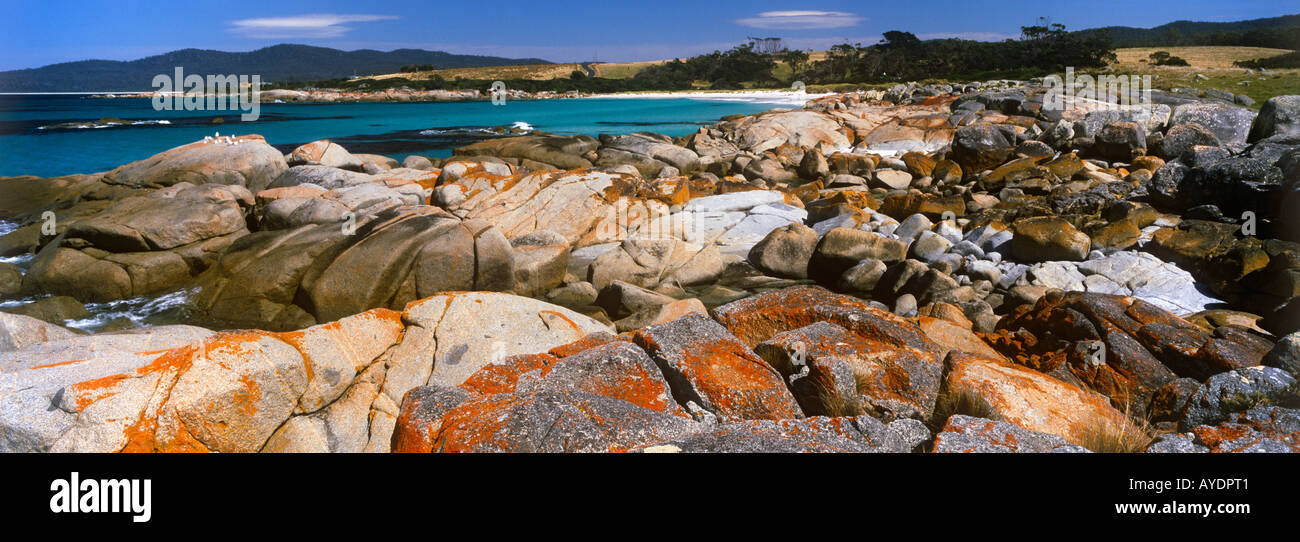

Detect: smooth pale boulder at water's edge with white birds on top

[104,135,289,192]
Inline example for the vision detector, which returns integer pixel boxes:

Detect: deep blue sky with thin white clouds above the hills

[0,0,1300,70]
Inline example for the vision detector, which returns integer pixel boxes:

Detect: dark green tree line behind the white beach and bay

[263,25,1114,92]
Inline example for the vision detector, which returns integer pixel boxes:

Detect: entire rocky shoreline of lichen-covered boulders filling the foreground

[0,82,1300,452]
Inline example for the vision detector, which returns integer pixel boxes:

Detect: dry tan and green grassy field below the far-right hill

[1113,47,1300,108]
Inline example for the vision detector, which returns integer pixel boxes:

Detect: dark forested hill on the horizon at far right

[1078,14,1300,49]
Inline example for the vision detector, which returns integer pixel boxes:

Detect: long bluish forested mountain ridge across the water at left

[0,44,551,92]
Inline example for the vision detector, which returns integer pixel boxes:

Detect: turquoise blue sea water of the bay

[0,95,776,177]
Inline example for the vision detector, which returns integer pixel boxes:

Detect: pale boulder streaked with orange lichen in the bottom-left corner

[0,311,402,452]
